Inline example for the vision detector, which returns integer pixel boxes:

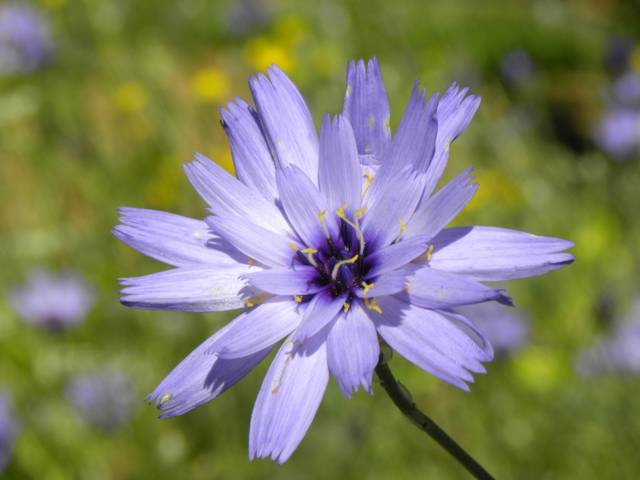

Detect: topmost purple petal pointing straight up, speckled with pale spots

[342,58,391,163]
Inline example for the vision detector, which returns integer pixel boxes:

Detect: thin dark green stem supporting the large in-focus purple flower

[376,355,494,480]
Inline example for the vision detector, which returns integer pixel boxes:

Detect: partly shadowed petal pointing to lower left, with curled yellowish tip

[147,324,273,418]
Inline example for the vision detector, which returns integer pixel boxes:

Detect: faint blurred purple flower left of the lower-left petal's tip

[67,370,134,430]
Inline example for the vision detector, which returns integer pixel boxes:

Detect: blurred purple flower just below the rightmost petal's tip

[459,303,529,356]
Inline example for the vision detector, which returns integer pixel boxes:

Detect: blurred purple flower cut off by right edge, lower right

[577,298,640,376]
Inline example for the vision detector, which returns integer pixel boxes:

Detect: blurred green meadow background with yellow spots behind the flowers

[0,0,640,479]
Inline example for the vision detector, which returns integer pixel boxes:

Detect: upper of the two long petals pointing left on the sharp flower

[113,207,247,267]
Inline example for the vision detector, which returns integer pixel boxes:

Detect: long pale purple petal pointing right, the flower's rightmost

[430,227,574,281]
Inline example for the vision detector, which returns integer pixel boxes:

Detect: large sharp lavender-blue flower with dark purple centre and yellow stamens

[114,59,573,462]
